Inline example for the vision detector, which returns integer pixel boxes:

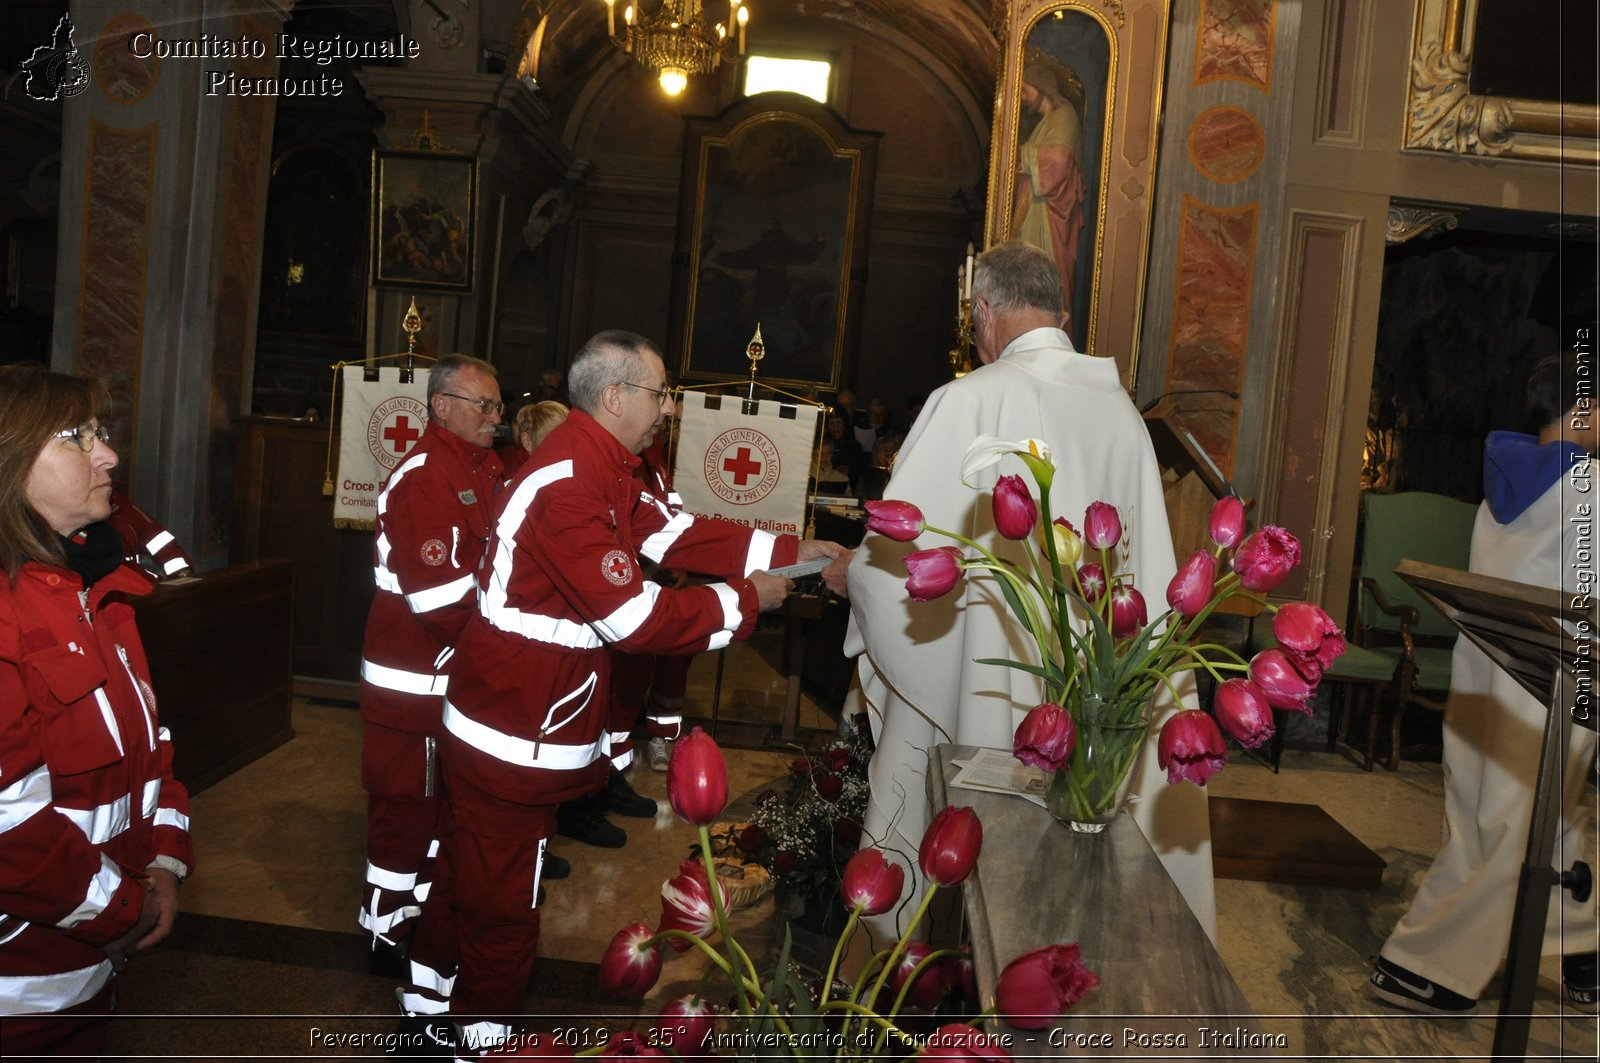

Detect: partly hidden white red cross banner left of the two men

[333,365,427,528]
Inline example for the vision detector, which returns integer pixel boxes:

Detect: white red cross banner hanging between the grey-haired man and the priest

[674,391,818,535]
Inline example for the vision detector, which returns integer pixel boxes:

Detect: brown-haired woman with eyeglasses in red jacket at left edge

[0,365,194,1057]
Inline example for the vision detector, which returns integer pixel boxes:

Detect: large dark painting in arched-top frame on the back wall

[672,93,877,391]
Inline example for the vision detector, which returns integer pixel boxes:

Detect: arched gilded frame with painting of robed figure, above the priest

[984,0,1168,383]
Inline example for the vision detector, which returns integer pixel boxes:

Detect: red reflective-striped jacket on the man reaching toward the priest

[443,410,798,805]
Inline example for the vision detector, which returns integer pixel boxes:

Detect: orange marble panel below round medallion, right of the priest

[1165,195,1258,472]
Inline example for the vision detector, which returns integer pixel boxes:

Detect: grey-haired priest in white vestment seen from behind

[845,242,1216,940]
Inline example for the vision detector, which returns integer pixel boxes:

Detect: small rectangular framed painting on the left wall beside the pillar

[373,149,478,293]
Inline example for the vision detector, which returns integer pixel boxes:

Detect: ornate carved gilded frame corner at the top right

[1405,0,1600,166]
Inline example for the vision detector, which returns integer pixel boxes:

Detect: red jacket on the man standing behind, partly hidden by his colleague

[362,421,501,733]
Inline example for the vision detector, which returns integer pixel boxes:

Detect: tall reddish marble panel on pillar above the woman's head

[77,120,155,467]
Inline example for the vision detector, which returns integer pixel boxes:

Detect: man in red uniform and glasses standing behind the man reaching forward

[360,354,550,986]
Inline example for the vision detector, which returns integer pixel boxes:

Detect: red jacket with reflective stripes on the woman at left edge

[0,562,194,1015]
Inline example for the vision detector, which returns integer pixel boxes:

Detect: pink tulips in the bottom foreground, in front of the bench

[582,728,1099,1060]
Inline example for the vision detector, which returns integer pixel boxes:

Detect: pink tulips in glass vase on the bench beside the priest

[867,435,1344,832]
